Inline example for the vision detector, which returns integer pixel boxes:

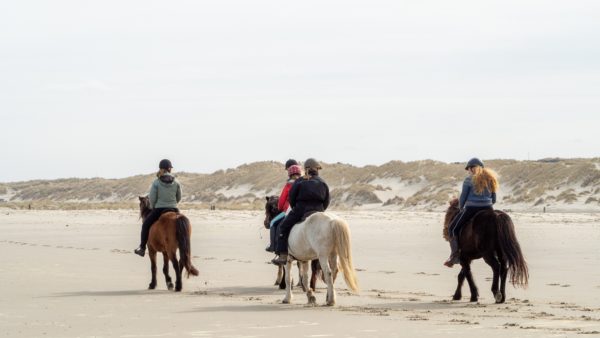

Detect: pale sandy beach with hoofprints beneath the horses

[0,209,600,337]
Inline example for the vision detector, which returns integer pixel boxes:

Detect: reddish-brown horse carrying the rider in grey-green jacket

[140,196,198,291]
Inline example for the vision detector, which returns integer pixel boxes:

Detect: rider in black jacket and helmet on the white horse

[271,158,329,265]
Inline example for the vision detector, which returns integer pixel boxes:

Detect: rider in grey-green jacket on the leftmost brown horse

[134,159,181,257]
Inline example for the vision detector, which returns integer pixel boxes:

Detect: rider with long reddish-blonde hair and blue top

[444,158,498,267]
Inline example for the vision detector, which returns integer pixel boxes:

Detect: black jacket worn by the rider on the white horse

[289,176,329,213]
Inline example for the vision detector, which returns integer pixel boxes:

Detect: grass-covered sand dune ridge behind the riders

[0,158,600,211]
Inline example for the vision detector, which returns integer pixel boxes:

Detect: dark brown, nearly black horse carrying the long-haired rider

[443,199,529,304]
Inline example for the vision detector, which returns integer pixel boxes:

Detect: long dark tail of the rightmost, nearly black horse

[496,212,529,288]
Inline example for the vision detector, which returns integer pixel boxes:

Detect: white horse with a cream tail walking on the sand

[283,212,358,306]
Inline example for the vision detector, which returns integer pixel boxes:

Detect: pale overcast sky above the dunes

[0,0,600,182]
